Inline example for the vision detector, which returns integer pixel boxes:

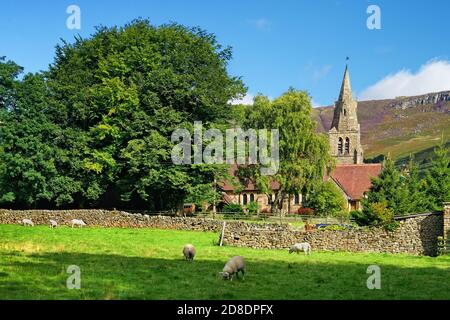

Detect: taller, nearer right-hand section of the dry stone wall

[224,213,443,255]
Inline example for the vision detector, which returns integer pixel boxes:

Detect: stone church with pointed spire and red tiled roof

[221,66,382,213]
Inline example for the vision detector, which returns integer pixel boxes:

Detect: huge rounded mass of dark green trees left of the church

[0,20,245,209]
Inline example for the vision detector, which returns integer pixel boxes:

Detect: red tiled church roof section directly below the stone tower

[330,163,382,200]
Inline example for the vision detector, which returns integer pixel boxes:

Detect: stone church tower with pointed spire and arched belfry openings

[328,66,363,164]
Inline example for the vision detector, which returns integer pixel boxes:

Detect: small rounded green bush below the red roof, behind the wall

[306,181,347,217]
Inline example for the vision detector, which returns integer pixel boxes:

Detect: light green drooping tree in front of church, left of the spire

[243,88,333,212]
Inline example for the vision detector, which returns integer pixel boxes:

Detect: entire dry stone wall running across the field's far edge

[0,209,450,255]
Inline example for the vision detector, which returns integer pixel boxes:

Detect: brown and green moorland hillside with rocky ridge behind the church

[313,91,450,162]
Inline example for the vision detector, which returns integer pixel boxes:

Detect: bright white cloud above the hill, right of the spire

[358,59,450,100]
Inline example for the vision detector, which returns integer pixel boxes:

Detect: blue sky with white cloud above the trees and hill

[0,0,450,105]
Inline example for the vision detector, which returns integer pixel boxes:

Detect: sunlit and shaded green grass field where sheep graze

[0,225,450,299]
